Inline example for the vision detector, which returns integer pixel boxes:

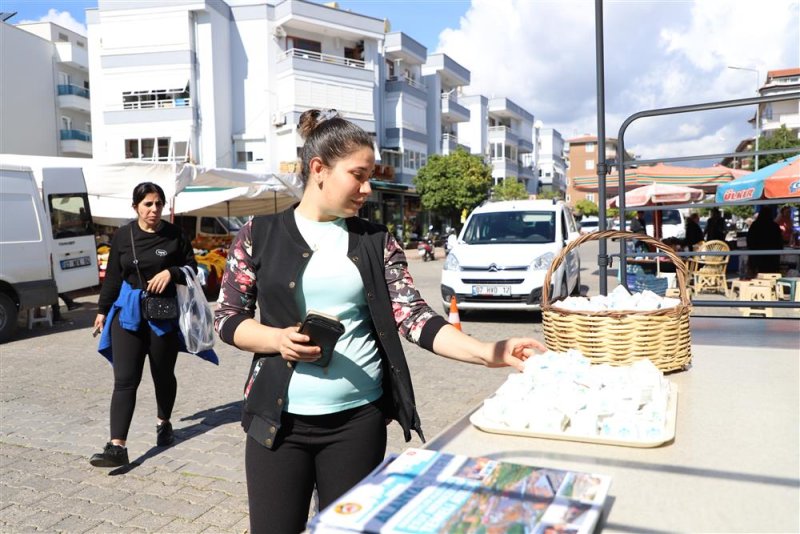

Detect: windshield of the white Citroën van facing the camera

[464,211,556,245]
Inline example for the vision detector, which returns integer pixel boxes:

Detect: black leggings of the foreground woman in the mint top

[245,403,386,534]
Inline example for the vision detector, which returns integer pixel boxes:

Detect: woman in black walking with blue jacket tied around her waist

[90,182,197,467]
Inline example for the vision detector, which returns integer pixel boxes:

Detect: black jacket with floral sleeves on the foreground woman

[215,208,447,448]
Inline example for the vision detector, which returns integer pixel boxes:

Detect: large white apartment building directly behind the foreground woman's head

[87,0,384,172]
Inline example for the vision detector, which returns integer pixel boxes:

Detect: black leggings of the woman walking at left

[111,314,179,440]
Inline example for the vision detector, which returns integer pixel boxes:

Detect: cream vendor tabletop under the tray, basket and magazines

[426,317,800,532]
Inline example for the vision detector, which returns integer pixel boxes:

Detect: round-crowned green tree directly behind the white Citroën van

[414,150,492,221]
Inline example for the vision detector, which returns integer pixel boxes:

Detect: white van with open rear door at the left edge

[0,163,98,341]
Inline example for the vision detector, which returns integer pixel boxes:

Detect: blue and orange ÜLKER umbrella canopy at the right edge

[716,155,800,203]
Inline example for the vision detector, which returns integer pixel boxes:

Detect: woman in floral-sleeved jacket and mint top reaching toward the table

[215,109,544,534]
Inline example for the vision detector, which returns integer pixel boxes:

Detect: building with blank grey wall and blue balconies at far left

[0,22,92,157]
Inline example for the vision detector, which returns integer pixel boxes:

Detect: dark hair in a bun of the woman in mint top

[297,109,373,184]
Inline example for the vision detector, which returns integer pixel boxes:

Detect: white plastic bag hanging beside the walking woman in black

[175,266,214,354]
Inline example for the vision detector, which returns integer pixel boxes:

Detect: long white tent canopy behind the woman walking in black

[0,154,303,226]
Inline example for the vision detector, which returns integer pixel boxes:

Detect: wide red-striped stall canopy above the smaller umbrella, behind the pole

[573,163,739,197]
